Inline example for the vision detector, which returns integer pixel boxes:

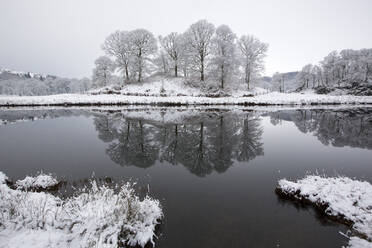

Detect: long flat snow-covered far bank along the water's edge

[0,92,372,107]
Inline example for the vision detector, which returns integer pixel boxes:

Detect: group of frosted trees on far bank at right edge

[297,49,372,91]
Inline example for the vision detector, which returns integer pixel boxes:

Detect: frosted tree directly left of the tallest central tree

[159,32,184,77]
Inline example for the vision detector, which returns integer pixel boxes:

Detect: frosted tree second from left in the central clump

[102,31,133,82]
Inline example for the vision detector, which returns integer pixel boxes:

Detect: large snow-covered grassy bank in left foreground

[0,171,163,248]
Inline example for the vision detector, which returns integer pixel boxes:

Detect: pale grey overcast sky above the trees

[0,0,372,77]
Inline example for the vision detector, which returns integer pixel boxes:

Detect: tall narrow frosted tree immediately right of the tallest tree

[212,25,237,89]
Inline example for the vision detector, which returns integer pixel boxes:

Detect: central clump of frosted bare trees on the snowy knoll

[93,20,268,88]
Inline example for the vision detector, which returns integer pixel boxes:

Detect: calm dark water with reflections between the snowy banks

[0,108,372,248]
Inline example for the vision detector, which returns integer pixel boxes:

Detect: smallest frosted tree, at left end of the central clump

[93,56,114,86]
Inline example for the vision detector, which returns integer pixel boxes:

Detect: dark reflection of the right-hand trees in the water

[269,108,372,149]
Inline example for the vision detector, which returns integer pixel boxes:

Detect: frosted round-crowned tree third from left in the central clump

[129,29,158,82]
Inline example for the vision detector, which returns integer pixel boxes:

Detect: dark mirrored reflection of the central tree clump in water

[94,112,263,177]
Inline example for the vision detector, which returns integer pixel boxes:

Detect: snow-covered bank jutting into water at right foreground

[276,175,372,247]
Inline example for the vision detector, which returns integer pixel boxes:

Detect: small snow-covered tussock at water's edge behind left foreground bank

[16,173,59,190]
